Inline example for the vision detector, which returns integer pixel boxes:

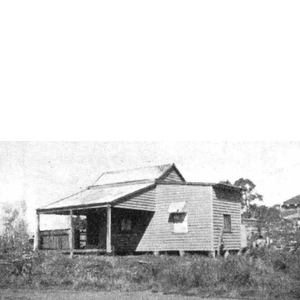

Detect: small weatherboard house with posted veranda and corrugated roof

[35,164,242,255]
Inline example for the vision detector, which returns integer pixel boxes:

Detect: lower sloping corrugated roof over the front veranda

[39,181,154,210]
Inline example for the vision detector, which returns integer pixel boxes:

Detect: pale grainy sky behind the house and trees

[0,141,300,232]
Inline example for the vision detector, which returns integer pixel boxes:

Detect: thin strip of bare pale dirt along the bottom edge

[0,289,244,300]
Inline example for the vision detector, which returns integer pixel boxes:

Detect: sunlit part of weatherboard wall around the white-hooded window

[136,184,213,251]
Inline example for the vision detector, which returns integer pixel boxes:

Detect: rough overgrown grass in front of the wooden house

[0,249,300,299]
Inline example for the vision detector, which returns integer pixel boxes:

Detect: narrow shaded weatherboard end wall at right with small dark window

[212,187,242,250]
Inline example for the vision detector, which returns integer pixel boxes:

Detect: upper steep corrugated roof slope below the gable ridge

[93,164,174,185]
